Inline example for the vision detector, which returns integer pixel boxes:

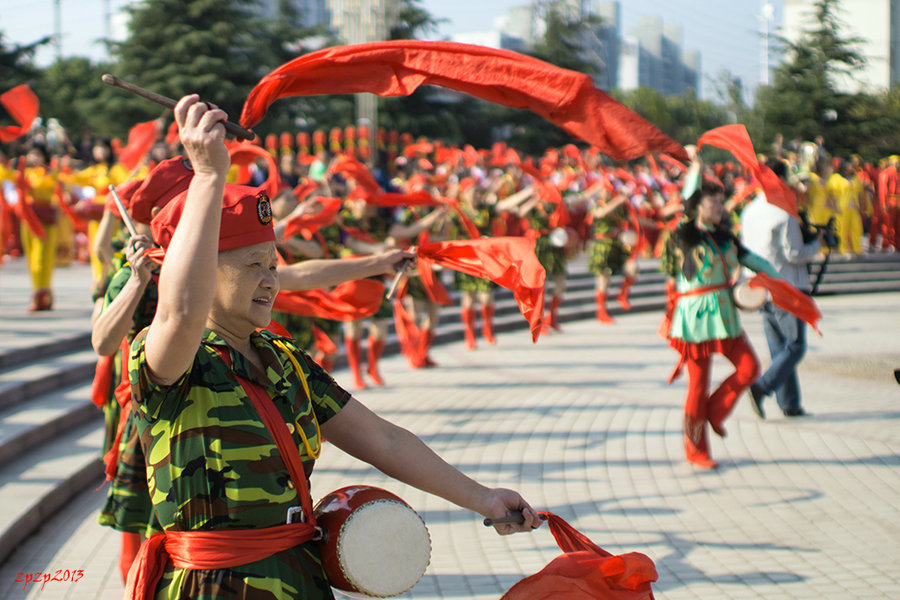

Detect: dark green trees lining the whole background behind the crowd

[0,0,900,160]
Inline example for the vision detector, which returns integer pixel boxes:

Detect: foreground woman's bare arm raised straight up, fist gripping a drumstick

[145,94,230,385]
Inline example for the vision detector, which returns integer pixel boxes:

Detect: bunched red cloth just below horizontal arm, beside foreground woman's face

[273,279,384,321]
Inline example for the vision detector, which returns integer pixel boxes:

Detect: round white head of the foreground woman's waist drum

[338,500,431,598]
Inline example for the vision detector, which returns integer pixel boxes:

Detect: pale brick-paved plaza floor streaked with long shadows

[0,255,900,600]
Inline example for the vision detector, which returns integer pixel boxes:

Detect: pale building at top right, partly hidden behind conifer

[782,0,900,93]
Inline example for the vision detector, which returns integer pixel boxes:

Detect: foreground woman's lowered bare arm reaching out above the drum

[322,400,541,534]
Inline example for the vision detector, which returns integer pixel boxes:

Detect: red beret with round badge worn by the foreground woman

[150,183,275,252]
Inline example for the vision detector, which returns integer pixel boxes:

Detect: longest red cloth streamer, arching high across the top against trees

[241,40,687,160]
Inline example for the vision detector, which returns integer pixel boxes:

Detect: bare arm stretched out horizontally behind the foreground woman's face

[278,250,415,290]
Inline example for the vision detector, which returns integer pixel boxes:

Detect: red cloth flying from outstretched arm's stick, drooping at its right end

[418,237,547,341]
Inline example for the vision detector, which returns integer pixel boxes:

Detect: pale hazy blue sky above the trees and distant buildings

[0,0,781,99]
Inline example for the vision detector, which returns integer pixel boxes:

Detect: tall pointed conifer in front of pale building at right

[754,0,864,153]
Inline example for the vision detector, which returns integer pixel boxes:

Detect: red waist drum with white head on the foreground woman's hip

[315,485,431,598]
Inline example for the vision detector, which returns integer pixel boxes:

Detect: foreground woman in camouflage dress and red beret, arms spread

[126,95,541,600]
